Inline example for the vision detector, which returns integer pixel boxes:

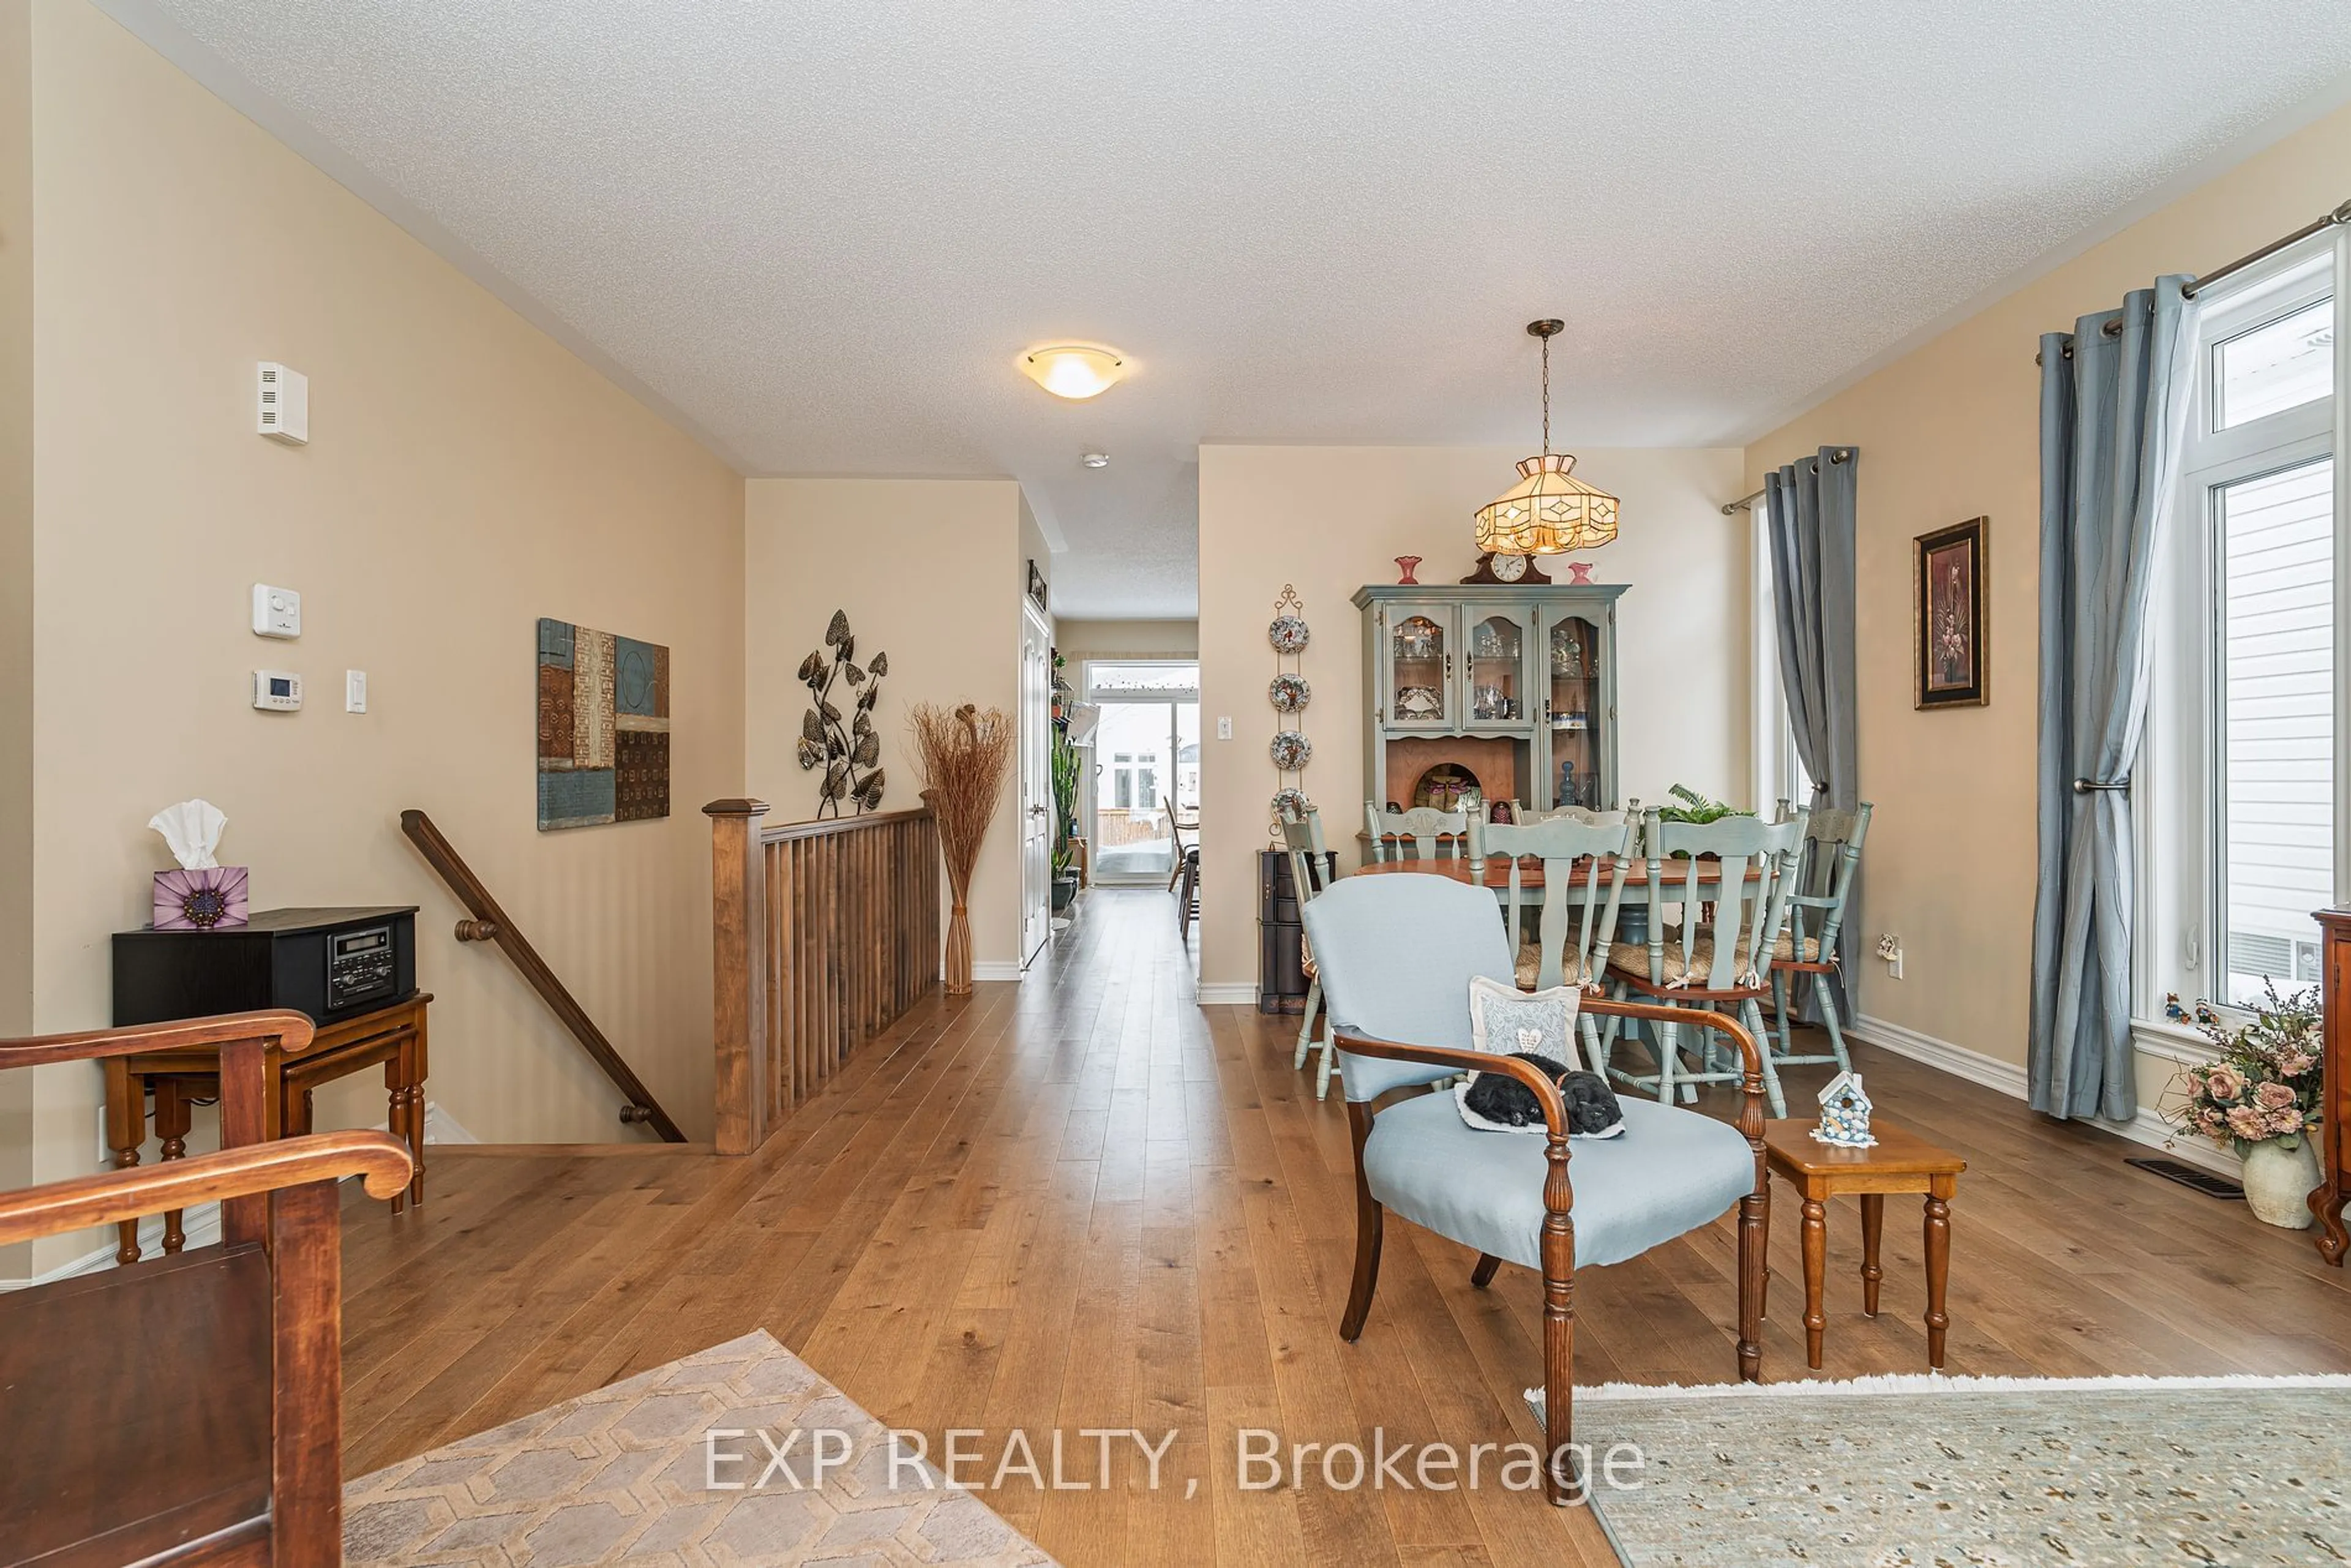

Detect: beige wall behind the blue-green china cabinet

[1199,447,1752,997]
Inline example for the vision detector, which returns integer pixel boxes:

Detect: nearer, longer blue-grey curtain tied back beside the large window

[2027,277,2196,1119]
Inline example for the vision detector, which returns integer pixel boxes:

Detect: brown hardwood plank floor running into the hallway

[345,891,2351,1568]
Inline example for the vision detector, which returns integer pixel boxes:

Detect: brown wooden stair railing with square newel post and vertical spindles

[703,799,940,1154]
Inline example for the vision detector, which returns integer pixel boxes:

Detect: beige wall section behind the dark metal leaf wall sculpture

[743,479,1046,975]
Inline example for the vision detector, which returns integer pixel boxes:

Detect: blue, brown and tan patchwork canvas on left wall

[538,618,670,832]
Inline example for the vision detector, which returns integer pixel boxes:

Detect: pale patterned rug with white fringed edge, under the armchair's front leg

[1528,1378,2351,1568]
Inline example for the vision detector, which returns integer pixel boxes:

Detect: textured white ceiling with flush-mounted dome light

[101,0,2351,616]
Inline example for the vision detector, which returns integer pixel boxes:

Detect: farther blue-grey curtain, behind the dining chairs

[1758,447,1862,1020]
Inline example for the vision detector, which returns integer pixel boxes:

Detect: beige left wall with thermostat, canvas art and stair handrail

[16,0,743,1262]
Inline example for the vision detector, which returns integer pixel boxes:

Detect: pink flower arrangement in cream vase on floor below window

[2163,980,2320,1229]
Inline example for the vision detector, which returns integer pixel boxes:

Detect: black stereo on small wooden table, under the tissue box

[115,905,416,1027]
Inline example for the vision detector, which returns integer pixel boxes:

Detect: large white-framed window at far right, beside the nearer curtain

[2132,240,2351,1020]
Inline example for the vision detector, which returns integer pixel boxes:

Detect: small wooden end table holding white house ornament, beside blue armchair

[1763,1119,1968,1370]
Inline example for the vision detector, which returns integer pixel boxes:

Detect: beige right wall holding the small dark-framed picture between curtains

[1747,98,2351,1103]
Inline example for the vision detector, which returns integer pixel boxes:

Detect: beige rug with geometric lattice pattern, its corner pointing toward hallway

[343,1333,1053,1568]
